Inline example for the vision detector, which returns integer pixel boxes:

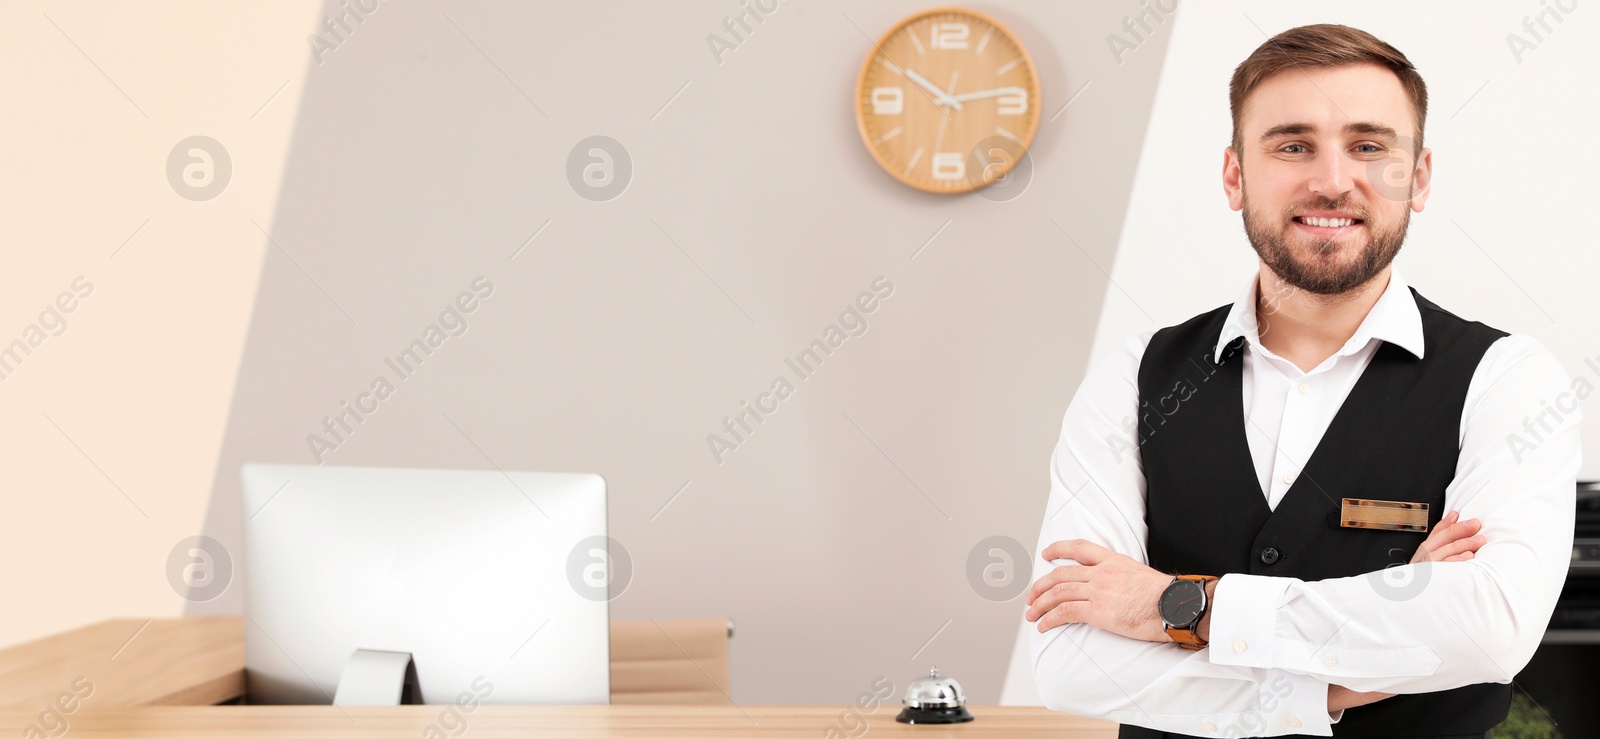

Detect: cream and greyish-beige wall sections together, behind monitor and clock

[0,0,1171,704]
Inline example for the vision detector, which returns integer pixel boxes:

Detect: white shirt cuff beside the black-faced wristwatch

[1208,573,1286,668]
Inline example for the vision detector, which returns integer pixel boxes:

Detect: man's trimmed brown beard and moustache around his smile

[1243,186,1411,296]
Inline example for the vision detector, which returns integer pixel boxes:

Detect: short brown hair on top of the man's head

[1227,22,1427,157]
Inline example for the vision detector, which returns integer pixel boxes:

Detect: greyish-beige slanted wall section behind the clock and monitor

[189,0,1177,704]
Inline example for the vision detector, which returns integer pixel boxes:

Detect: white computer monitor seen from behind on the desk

[242,464,611,704]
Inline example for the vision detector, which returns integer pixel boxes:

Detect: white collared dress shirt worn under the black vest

[1029,269,1581,736]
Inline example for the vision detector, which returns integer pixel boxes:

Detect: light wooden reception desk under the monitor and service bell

[0,617,1117,739]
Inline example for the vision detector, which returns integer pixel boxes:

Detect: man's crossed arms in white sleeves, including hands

[1029,334,1581,736]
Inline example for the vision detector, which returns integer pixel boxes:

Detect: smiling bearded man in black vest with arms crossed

[1026,26,1581,737]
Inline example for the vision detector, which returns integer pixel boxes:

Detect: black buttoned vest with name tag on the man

[1120,290,1512,737]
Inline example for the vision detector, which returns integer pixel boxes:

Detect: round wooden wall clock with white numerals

[856,8,1038,194]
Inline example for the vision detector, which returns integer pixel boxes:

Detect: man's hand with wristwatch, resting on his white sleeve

[1026,539,1173,641]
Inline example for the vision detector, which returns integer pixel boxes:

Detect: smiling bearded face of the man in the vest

[1222,64,1432,294]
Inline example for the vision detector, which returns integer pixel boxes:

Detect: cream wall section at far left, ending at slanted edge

[0,0,318,645]
